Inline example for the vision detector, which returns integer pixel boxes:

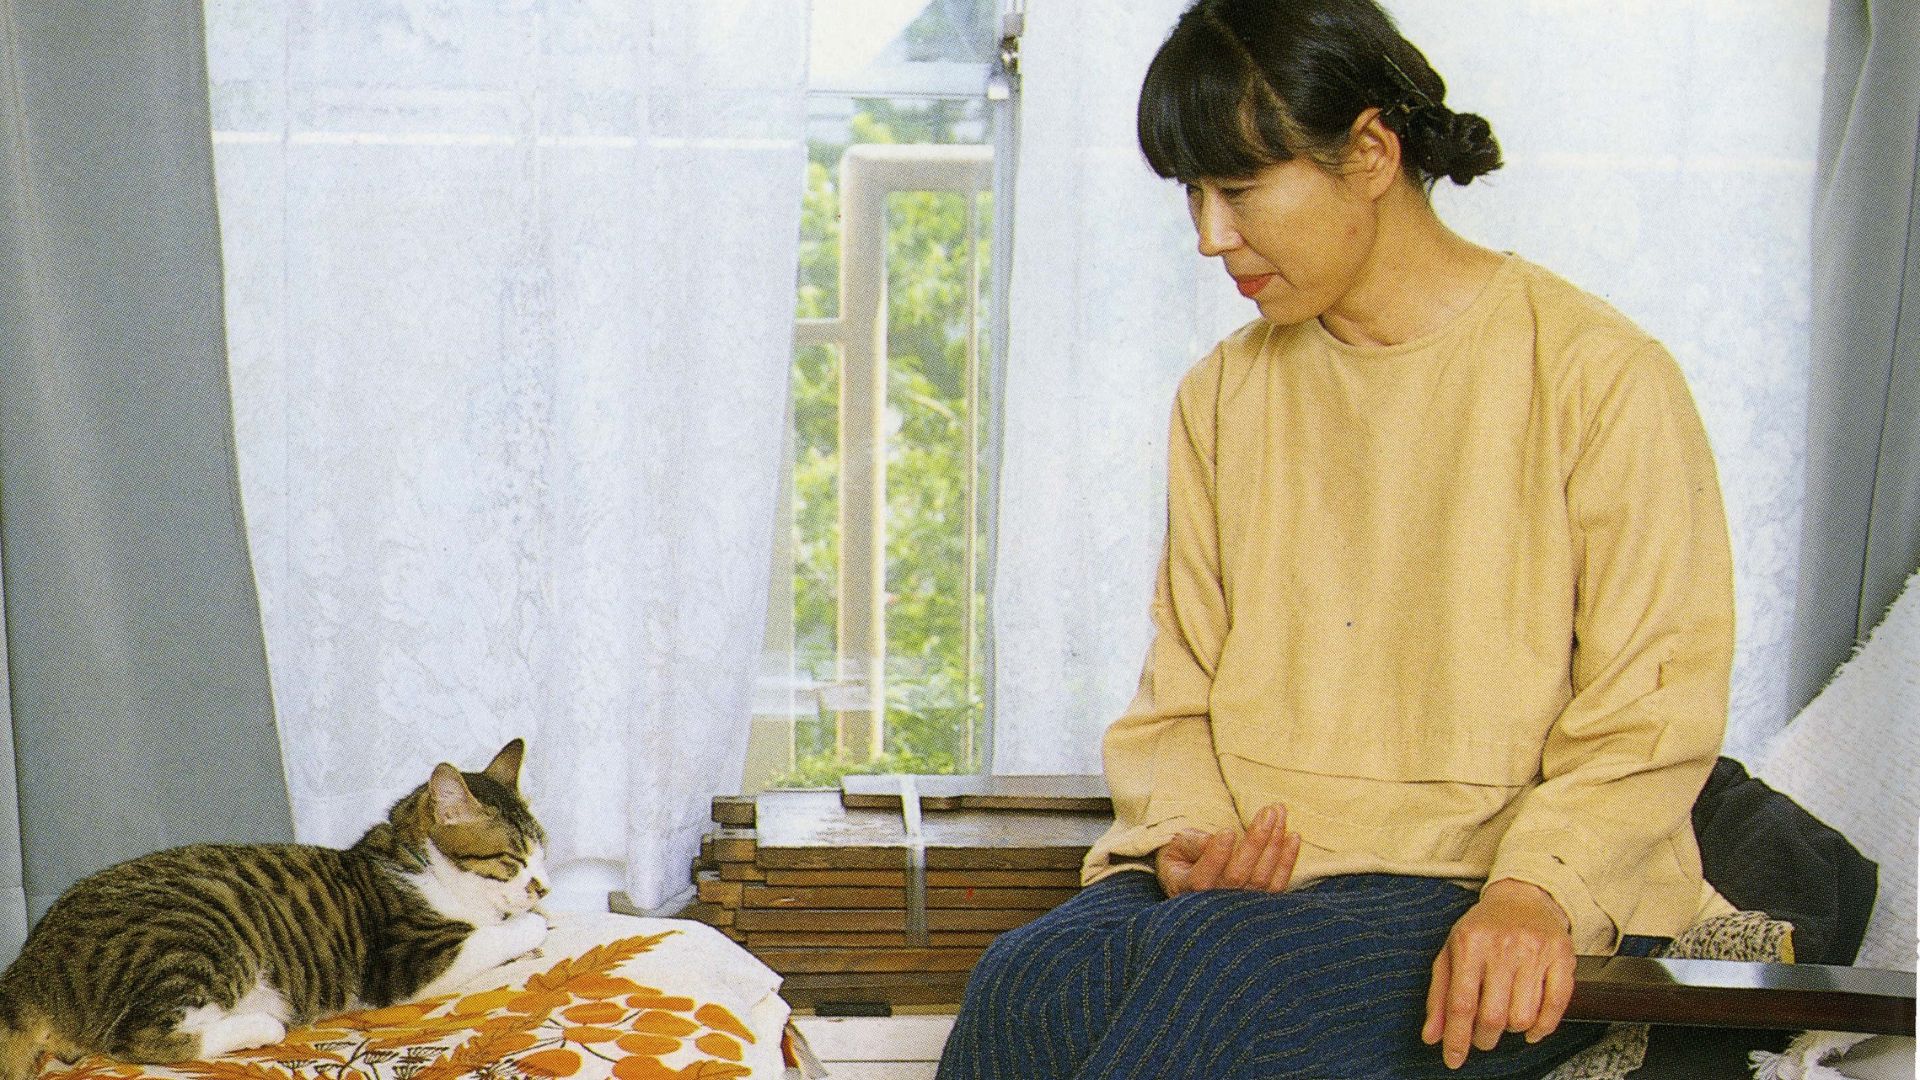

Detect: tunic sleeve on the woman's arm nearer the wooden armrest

[1488,344,1734,951]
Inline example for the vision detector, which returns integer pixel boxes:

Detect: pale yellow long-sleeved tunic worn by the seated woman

[1083,258,1734,953]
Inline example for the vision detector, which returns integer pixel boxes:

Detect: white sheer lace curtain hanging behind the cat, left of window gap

[207,0,808,907]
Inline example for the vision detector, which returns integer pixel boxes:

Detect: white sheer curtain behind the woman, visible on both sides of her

[995,0,1826,773]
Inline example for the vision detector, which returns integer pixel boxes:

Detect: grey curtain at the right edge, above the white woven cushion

[1789,0,1920,709]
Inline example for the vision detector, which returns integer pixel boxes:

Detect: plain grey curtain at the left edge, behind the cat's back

[0,0,292,959]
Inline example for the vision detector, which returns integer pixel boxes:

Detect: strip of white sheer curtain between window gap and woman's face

[993,0,1252,773]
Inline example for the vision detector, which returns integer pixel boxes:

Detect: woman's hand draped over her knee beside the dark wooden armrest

[1421,878,1572,1068]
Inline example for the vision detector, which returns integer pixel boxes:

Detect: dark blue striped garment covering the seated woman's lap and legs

[939,872,1659,1080]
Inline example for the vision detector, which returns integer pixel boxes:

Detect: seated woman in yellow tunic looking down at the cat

[941,0,1732,1080]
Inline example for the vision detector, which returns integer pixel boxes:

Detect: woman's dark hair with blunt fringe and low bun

[1139,0,1500,190]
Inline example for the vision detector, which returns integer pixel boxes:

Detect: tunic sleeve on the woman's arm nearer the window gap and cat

[1083,356,1240,884]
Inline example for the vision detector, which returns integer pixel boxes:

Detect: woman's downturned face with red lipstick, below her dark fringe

[1187,156,1377,325]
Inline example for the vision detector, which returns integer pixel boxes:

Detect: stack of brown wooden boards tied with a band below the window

[682,776,1112,1009]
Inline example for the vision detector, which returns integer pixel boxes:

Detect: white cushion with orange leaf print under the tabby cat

[40,913,787,1080]
